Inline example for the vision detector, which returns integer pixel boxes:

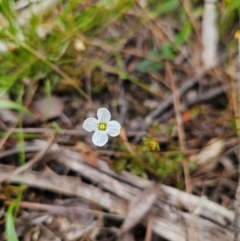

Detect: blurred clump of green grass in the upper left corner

[0,0,137,99]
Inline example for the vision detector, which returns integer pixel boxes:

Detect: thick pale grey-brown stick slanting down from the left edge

[0,164,127,215]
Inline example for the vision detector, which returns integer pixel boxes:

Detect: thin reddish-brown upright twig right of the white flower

[166,63,197,240]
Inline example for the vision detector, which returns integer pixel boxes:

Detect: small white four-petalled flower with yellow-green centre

[83,108,121,146]
